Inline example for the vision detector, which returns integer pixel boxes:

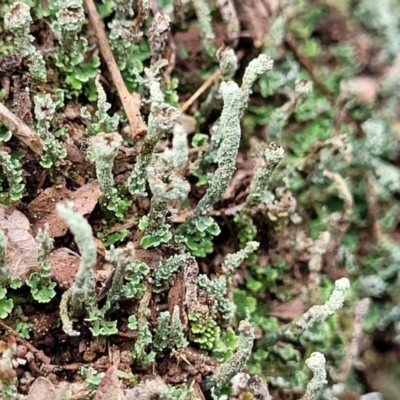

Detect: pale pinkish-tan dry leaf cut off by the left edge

[0,204,39,279]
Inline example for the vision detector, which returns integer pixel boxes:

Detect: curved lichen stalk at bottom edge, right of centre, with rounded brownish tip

[203,320,255,392]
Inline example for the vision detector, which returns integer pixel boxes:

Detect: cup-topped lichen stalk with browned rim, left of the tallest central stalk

[140,157,190,248]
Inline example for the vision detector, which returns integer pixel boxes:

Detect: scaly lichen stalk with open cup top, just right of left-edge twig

[33,91,67,168]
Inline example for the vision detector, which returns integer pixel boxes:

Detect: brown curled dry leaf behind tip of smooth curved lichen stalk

[28,181,100,238]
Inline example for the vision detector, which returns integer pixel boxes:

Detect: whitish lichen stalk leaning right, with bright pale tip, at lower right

[262,278,350,347]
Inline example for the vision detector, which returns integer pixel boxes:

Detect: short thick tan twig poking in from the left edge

[0,103,43,155]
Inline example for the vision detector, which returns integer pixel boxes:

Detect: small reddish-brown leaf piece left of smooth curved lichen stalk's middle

[49,247,81,289]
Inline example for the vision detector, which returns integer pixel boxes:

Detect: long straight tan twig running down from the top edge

[84,0,147,139]
